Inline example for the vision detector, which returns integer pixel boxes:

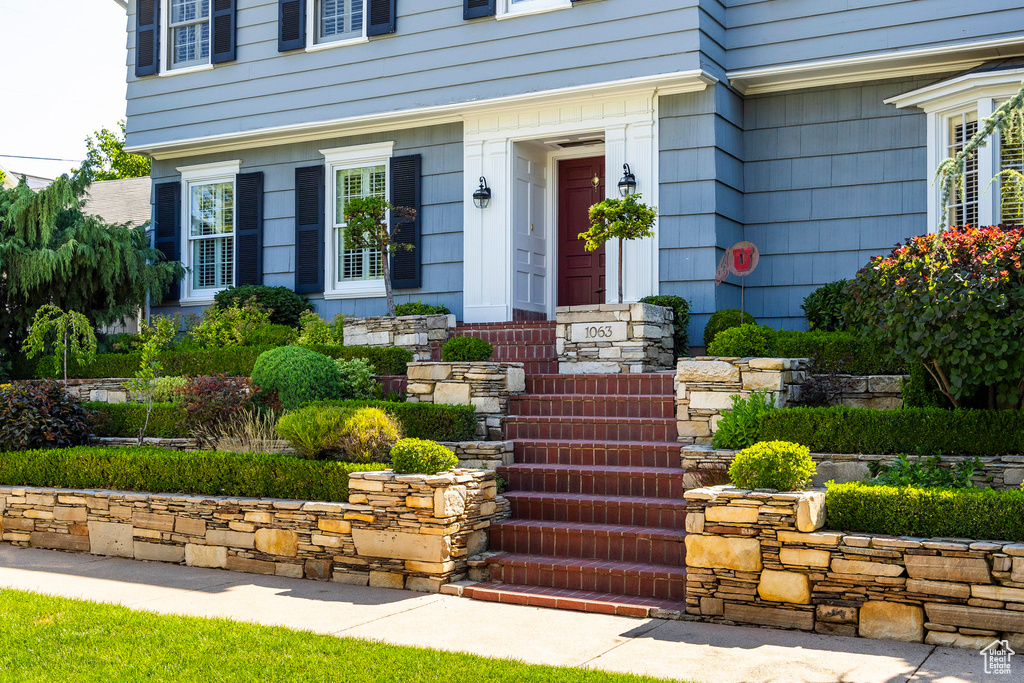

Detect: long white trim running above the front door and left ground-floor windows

[125,69,718,160]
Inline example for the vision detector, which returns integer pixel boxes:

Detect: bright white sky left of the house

[0,0,127,178]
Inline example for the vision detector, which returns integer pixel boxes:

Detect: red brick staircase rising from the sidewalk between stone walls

[463,368,686,616]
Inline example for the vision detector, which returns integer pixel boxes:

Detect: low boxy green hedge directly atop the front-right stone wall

[825,483,1024,542]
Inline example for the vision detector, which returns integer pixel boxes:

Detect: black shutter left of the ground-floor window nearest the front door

[295,166,326,294]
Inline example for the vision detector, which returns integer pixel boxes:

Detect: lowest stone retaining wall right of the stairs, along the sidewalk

[685,486,1024,651]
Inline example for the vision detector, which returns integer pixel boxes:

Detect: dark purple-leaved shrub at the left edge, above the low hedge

[0,382,92,450]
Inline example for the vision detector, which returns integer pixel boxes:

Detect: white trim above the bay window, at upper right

[726,35,1024,95]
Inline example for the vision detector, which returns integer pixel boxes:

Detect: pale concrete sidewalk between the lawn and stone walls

[0,545,991,683]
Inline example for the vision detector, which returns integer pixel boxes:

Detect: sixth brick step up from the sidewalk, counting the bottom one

[515,439,682,468]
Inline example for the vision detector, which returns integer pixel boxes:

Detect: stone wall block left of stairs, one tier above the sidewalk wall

[407,361,526,441]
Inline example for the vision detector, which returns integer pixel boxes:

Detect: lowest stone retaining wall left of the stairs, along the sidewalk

[0,470,505,591]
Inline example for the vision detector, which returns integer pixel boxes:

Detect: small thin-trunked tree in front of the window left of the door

[345,197,416,317]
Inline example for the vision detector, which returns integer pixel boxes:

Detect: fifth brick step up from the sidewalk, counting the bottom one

[498,464,683,501]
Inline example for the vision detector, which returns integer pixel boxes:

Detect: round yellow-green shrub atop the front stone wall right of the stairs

[729,441,817,490]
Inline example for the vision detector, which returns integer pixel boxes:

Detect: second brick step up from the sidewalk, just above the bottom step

[487,553,686,601]
